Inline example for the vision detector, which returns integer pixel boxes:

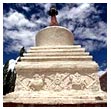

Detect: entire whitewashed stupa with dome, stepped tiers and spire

[3,7,106,106]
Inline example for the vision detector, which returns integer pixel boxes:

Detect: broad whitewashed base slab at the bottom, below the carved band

[3,90,107,104]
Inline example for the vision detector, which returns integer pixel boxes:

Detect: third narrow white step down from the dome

[23,52,89,57]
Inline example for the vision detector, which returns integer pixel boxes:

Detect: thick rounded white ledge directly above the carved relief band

[16,61,98,74]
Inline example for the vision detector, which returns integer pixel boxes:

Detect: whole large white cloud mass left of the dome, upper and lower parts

[3,10,36,52]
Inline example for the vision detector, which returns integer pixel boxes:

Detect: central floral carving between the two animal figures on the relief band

[44,73,70,91]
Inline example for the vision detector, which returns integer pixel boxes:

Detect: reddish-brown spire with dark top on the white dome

[48,6,58,26]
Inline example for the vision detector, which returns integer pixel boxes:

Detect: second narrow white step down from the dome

[27,48,85,53]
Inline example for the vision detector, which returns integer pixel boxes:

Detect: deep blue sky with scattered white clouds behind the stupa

[3,3,107,74]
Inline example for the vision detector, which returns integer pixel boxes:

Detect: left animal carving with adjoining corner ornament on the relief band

[15,74,44,91]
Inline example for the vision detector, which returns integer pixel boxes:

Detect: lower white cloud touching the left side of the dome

[4,29,36,52]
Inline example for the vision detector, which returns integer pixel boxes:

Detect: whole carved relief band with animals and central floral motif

[15,72,99,91]
